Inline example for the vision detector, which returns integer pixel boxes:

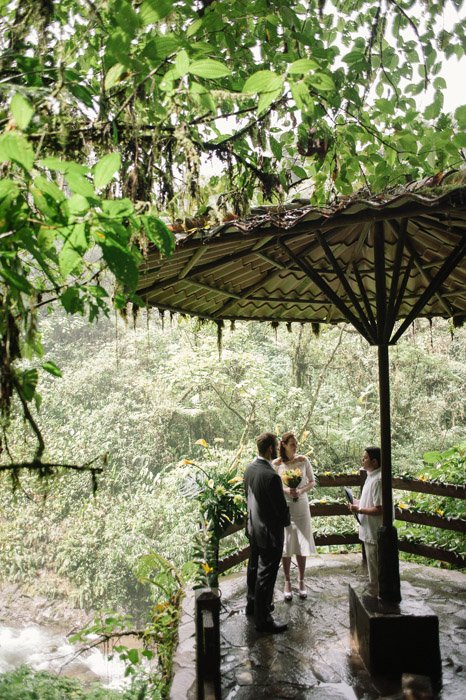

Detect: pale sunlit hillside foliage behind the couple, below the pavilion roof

[0,313,465,600]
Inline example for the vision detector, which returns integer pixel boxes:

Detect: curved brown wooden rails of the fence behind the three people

[218,470,466,574]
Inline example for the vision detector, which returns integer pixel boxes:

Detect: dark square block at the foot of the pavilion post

[349,585,442,680]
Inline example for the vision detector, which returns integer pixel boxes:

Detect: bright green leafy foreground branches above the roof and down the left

[0,0,466,474]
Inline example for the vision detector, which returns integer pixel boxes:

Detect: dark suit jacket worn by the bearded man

[244,457,290,549]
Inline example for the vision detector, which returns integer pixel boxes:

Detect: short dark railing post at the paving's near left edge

[195,588,221,700]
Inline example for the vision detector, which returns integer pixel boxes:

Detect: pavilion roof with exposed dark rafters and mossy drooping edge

[138,179,466,343]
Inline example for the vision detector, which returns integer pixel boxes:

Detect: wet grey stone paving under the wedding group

[171,554,466,700]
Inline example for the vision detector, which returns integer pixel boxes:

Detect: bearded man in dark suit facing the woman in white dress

[244,433,290,634]
